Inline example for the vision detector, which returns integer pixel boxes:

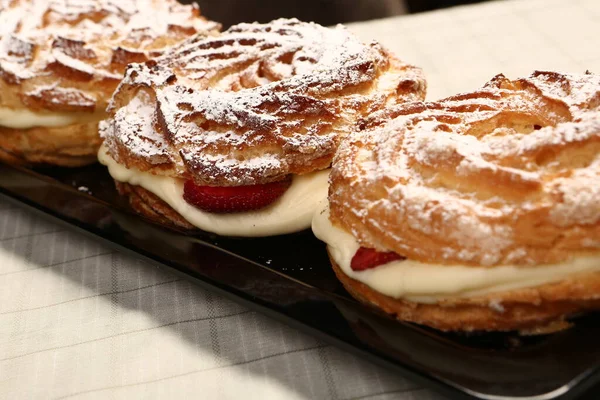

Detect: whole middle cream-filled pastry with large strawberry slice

[99,19,425,236]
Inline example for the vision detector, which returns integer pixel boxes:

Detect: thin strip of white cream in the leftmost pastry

[0,107,104,129]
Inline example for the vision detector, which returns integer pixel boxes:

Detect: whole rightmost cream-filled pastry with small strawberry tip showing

[313,72,600,333]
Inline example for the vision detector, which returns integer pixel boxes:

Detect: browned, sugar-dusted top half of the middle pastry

[101,19,426,186]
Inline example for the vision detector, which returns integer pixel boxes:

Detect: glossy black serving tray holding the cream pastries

[0,164,600,400]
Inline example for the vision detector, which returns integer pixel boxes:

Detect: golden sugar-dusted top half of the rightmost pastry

[329,72,600,266]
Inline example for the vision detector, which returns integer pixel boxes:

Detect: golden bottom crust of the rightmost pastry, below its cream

[330,256,600,334]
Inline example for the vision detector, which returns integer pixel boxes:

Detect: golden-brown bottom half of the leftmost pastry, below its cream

[0,122,102,167]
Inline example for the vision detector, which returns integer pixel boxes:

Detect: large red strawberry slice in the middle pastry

[183,178,292,213]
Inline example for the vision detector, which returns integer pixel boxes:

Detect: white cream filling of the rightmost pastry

[312,200,600,303]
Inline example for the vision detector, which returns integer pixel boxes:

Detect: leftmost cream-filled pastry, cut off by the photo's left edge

[0,0,219,166]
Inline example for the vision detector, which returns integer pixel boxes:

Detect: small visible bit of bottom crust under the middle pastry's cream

[115,181,197,230]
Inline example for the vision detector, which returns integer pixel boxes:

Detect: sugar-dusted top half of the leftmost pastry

[0,0,219,113]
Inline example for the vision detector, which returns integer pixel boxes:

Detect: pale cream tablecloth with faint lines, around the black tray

[0,0,600,400]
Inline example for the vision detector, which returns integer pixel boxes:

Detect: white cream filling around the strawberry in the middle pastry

[98,146,329,237]
